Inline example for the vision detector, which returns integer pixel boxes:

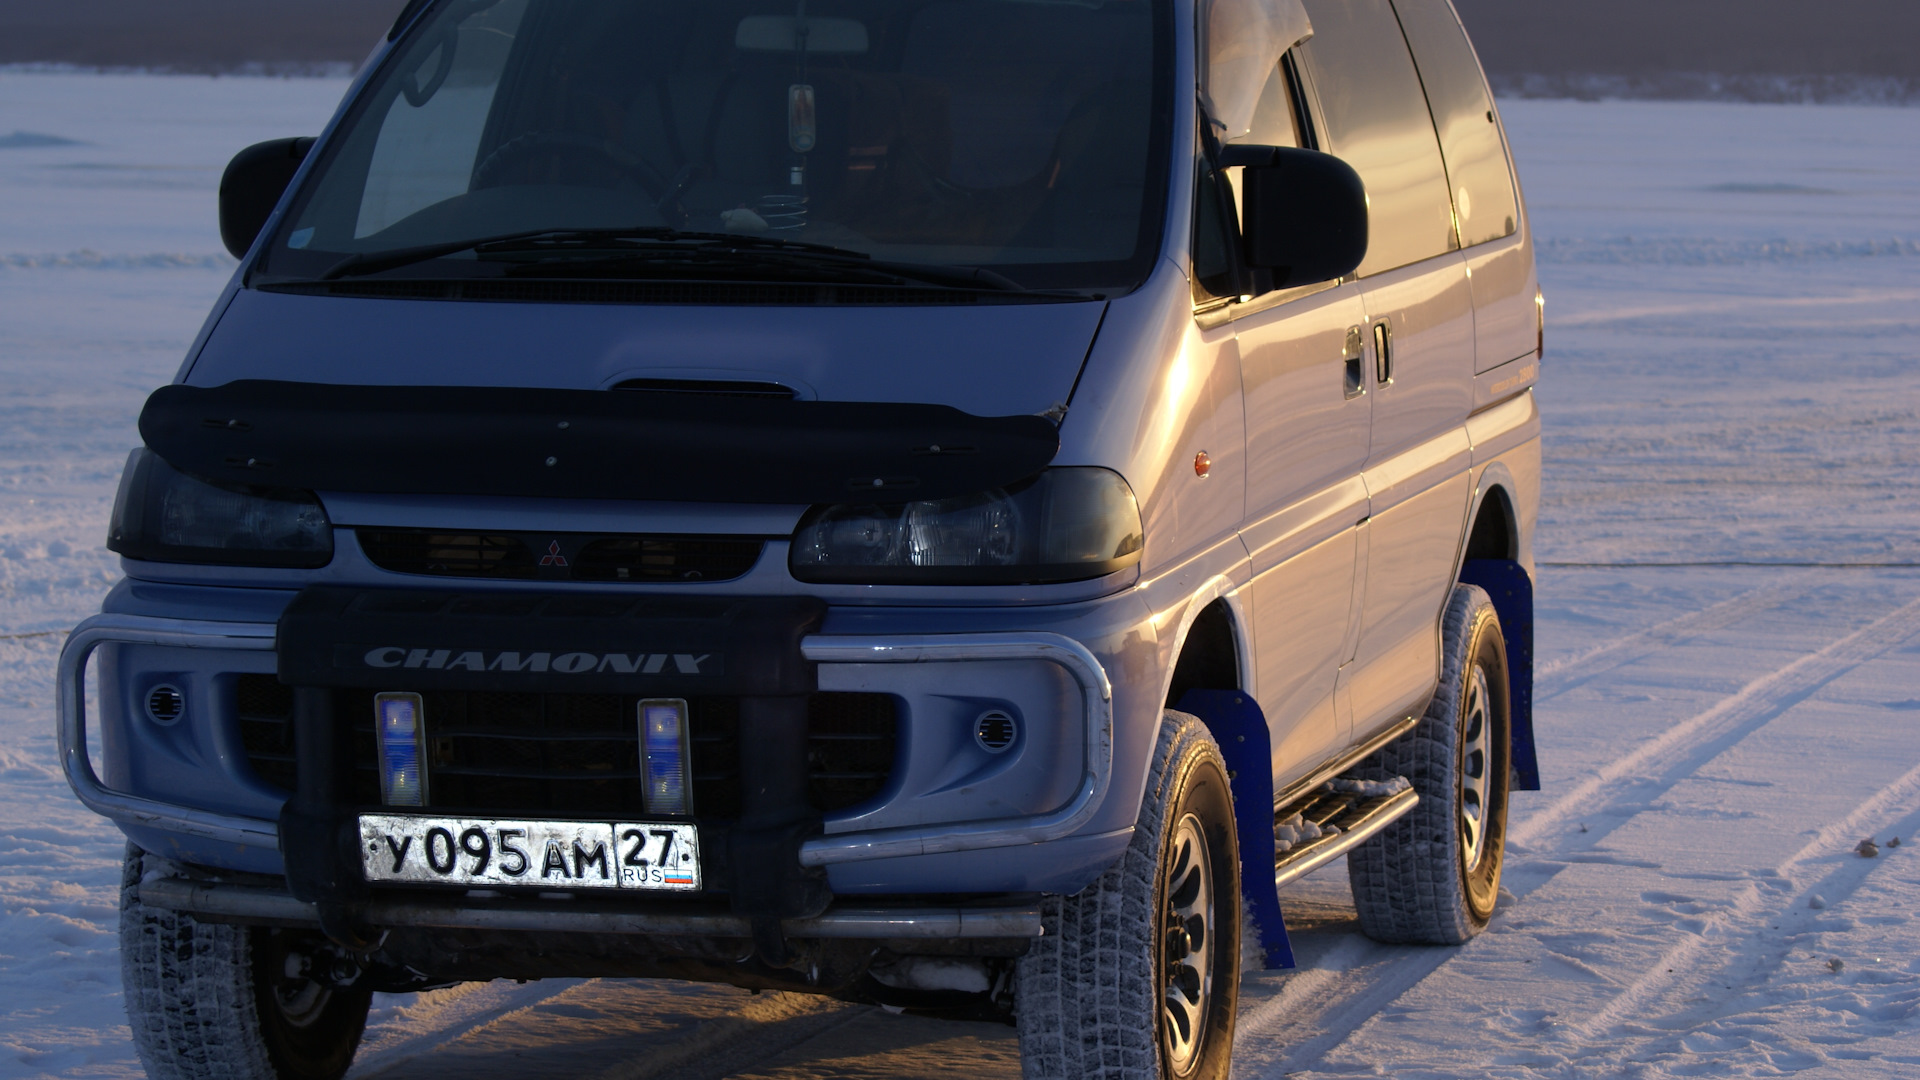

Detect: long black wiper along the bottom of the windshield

[321,229,1079,298]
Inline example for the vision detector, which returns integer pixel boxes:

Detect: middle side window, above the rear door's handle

[1306,0,1457,277]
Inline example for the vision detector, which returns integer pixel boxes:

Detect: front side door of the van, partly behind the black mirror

[1221,58,1373,786]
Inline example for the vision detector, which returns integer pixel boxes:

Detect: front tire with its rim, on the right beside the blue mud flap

[1014,711,1240,1080]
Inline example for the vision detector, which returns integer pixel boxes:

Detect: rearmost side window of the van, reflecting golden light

[1394,0,1521,246]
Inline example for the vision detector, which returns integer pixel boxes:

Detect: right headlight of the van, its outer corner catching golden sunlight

[793,469,1142,584]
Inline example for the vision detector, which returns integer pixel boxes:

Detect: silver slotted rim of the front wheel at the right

[1160,815,1213,1076]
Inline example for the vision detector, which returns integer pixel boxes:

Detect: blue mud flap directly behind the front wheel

[1175,690,1294,970]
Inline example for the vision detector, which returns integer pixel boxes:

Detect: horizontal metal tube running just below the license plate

[140,878,1041,940]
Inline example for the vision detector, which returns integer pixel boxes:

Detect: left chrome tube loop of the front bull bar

[58,615,280,849]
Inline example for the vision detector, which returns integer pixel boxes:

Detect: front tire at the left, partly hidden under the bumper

[119,844,372,1080]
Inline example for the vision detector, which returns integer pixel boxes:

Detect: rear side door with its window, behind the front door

[1306,0,1475,738]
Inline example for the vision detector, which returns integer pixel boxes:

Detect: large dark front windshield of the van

[255,0,1171,288]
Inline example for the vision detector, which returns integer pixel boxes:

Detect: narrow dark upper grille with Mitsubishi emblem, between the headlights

[355,528,766,584]
